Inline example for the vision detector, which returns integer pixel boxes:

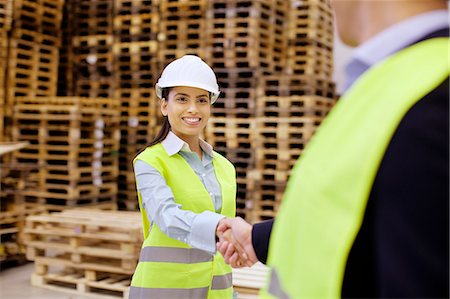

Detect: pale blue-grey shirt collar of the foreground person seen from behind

[345,9,449,90]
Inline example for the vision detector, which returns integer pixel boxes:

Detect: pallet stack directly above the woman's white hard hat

[158,0,209,69]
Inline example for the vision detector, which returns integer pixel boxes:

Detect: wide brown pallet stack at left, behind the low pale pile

[13,97,120,210]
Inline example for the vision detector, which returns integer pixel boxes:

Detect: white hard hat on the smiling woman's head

[155,55,220,104]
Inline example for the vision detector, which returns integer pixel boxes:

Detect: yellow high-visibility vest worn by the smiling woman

[130,143,236,299]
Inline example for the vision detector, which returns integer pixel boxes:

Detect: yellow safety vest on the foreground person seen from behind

[261,38,450,299]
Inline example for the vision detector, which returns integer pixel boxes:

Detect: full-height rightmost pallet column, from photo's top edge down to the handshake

[250,0,335,222]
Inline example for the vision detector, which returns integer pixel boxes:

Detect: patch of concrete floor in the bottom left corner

[0,263,92,299]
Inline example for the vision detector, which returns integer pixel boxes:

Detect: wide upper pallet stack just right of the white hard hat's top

[208,0,287,72]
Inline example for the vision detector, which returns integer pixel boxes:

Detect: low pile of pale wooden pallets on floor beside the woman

[24,209,142,274]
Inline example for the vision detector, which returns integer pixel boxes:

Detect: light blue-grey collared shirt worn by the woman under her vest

[134,132,224,254]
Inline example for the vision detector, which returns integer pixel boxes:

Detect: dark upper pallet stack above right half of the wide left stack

[71,0,116,98]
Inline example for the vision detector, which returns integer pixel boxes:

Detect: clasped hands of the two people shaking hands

[216,217,258,268]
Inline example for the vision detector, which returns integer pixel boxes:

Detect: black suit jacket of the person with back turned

[252,29,449,298]
